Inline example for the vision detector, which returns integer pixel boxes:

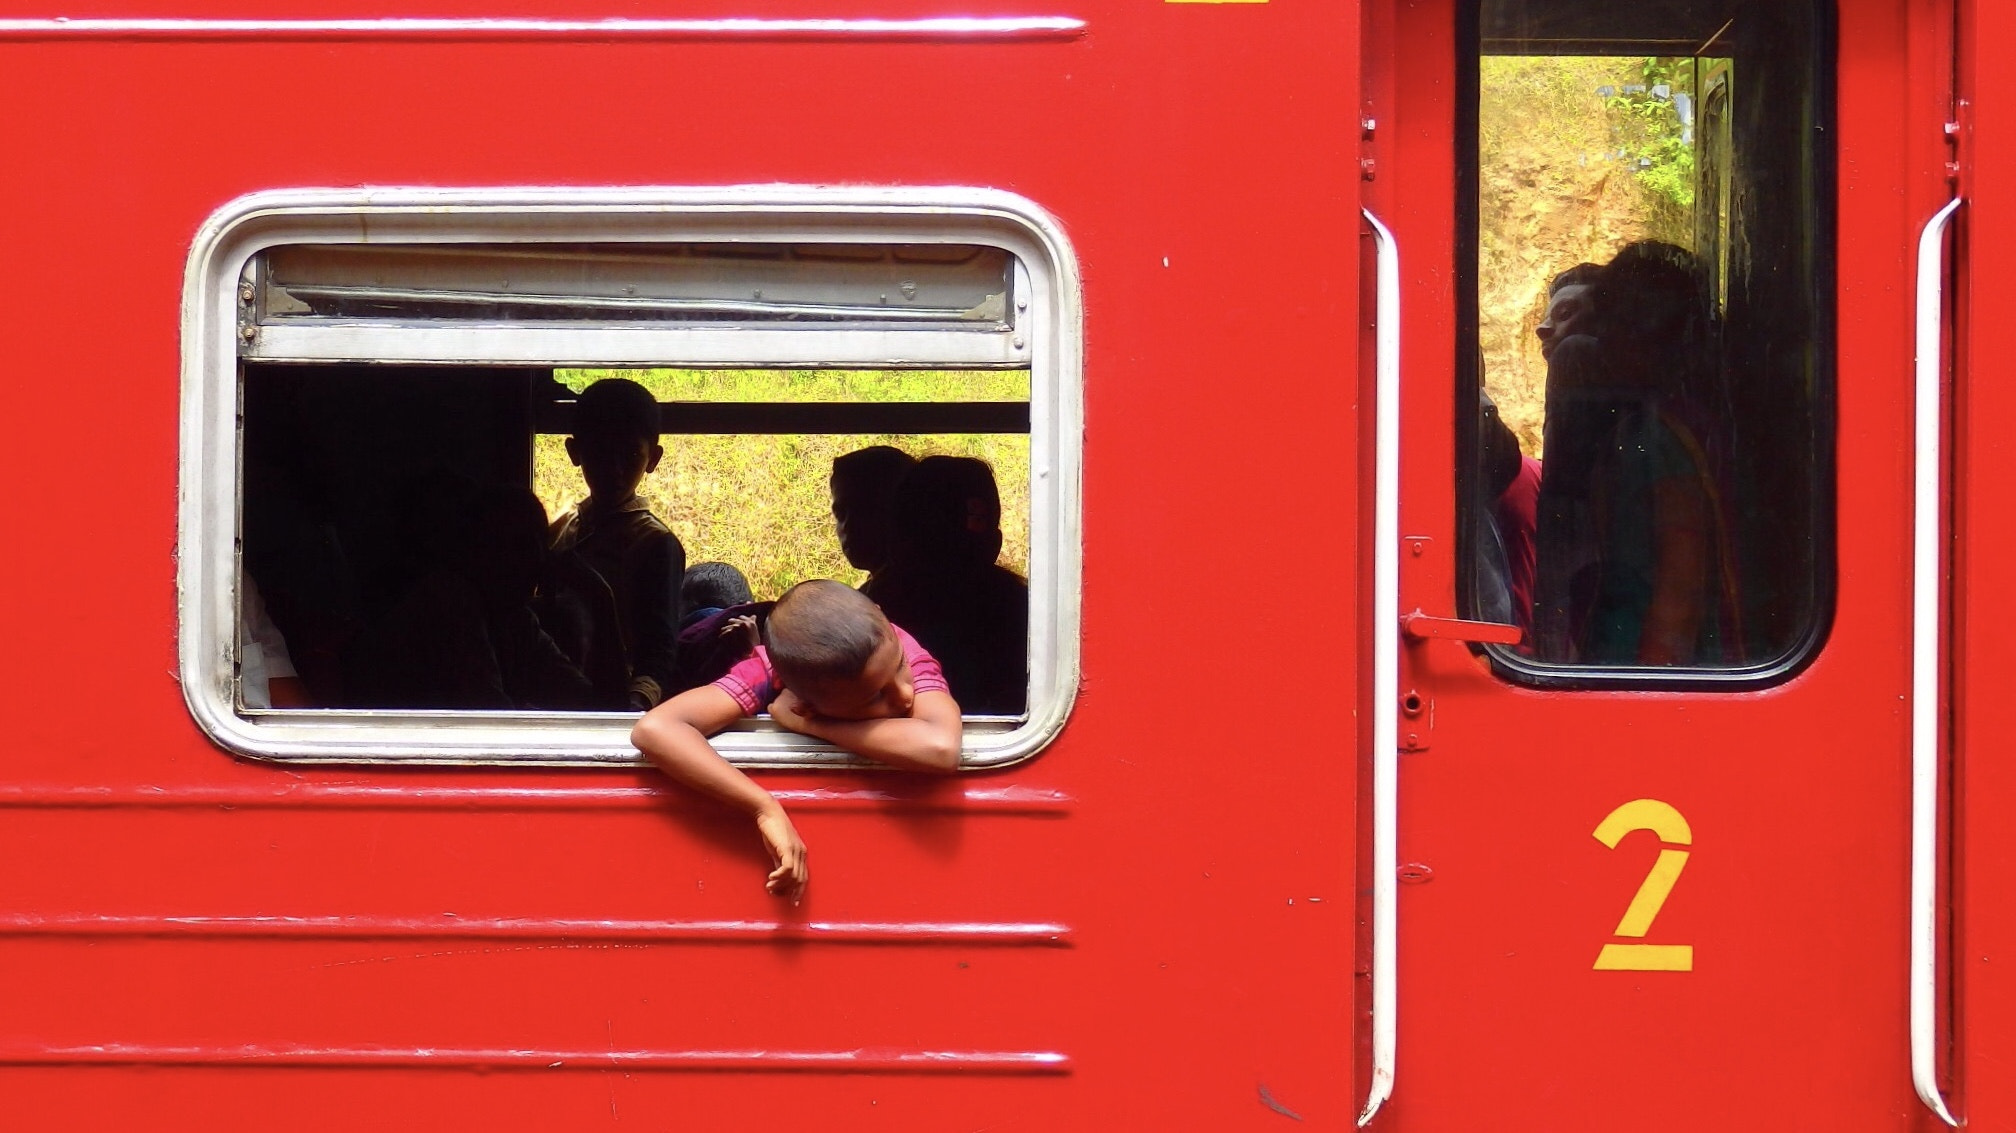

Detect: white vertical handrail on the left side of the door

[1359,210,1399,1125]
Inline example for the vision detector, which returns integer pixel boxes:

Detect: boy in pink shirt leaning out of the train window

[631,579,962,901]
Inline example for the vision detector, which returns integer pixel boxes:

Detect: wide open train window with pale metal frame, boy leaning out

[179,187,1081,766]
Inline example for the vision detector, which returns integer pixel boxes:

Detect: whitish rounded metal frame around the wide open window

[175,185,1085,770]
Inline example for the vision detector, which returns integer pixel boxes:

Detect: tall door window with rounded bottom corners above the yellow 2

[1458,0,1833,687]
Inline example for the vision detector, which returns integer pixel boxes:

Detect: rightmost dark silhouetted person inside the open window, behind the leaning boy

[861,456,1028,716]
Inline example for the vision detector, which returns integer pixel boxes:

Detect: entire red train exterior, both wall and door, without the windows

[0,0,2016,1129]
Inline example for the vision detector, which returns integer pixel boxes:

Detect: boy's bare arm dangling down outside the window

[631,685,806,901]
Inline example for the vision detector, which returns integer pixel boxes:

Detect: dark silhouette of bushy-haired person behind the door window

[1534,240,1736,667]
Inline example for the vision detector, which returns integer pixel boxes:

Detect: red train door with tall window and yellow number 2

[1365,0,1951,1131]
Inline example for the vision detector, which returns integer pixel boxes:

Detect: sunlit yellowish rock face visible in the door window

[1478,56,1693,456]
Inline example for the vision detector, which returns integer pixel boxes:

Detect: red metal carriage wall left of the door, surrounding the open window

[0,6,1357,1127]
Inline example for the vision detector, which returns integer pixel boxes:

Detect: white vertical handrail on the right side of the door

[1911,198,1960,1127]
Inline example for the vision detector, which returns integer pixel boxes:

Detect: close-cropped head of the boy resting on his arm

[764,579,915,720]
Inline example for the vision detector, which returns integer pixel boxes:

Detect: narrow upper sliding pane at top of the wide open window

[238,238,1040,369]
